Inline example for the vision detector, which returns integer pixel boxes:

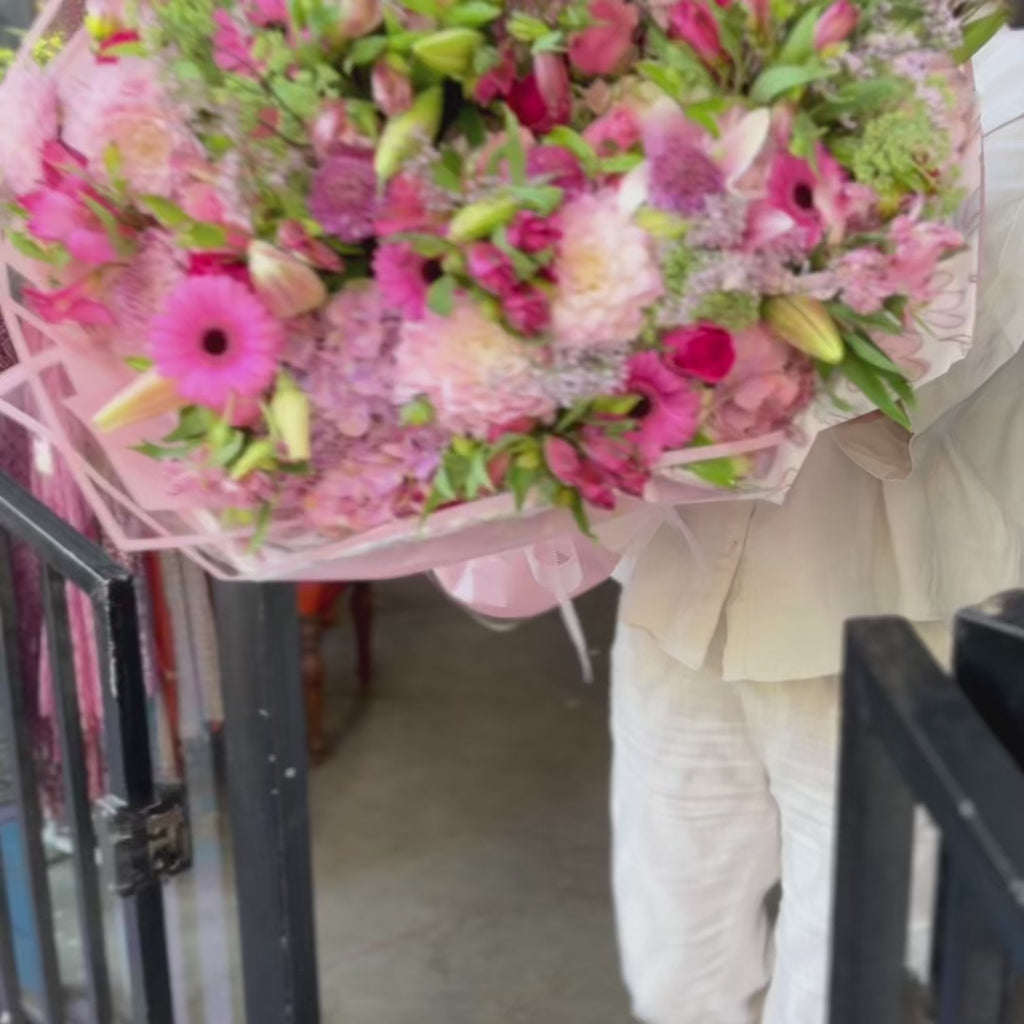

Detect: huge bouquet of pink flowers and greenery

[0,0,995,571]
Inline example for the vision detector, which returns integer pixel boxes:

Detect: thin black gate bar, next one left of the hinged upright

[43,565,114,1024]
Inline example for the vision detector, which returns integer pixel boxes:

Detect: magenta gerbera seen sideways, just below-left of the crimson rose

[626,351,700,464]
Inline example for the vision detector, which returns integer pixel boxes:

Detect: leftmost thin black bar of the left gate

[0,535,63,1024]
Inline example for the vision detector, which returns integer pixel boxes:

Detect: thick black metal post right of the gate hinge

[214,583,319,1024]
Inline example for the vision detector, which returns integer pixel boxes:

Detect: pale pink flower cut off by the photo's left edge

[0,60,57,196]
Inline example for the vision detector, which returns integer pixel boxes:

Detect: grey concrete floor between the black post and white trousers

[311,579,630,1024]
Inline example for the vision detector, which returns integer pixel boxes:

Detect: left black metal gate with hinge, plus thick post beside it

[0,474,319,1024]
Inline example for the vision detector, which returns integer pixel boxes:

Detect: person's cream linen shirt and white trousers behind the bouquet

[611,32,1024,1024]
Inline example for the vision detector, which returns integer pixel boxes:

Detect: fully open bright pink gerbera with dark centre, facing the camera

[150,274,285,409]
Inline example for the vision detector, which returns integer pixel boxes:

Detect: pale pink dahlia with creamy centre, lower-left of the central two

[395,297,555,437]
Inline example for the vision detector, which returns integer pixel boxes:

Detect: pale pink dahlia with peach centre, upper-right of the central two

[552,191,663,349]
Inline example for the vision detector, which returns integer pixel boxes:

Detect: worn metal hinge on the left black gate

[100,785,191,896]
